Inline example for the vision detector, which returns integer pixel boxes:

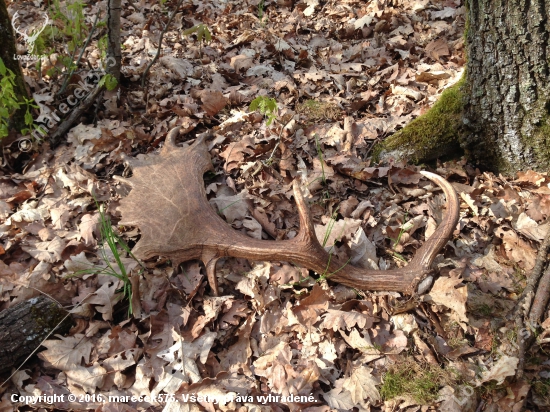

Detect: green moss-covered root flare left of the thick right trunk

[373,76,465,163]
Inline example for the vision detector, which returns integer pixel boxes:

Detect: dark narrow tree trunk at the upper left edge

[0,0,29,131]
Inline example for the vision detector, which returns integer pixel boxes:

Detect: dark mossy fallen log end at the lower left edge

[0,296,71,376]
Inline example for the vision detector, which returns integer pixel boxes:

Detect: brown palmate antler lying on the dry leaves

[120,128,460,296]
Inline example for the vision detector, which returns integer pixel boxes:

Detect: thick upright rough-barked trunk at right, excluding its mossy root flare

[461,0,550,173]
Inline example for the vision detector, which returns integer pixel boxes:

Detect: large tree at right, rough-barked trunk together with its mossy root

[374,0,550,174]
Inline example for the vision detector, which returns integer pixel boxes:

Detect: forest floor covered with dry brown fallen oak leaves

[0,0,550,412]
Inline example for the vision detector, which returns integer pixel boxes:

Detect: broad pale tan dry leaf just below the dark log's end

[38,334,94,371]
